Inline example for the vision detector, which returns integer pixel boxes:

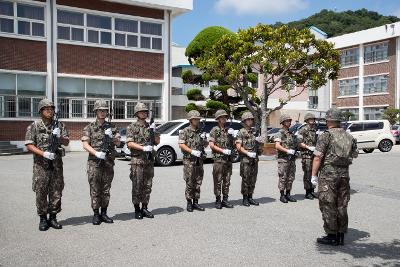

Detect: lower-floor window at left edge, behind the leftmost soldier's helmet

[0,73,46,118]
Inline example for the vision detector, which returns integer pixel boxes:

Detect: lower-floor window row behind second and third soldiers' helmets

[58,77,162,119]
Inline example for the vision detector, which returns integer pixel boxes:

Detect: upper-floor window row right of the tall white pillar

[57,9,162,50]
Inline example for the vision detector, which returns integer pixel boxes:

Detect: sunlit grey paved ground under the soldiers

[0,146,400,266]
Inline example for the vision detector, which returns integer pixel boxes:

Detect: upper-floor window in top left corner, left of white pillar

[0,0,45,37]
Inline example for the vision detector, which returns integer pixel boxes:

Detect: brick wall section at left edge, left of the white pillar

[0,37,47,72]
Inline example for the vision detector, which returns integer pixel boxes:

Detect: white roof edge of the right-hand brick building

[327,22,400,49]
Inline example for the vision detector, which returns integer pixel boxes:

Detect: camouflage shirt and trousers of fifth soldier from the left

[209,126,233,197]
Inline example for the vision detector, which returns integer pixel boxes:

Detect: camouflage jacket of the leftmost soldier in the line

[25,120,68,163]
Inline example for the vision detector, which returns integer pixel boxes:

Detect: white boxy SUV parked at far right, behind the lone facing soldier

[342,120,395,153]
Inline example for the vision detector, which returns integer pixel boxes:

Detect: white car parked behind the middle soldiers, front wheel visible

[123,119,242,166]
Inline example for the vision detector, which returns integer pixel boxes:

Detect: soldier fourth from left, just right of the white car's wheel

[178,110,208,212]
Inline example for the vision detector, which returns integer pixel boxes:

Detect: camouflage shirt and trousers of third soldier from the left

[126,120,157,205]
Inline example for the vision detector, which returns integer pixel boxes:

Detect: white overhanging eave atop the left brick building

[106,0,193,17]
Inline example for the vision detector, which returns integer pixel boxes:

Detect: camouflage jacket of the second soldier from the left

[81,120,120,160]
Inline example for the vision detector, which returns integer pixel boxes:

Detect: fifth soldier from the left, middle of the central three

[208,110,235,209]
